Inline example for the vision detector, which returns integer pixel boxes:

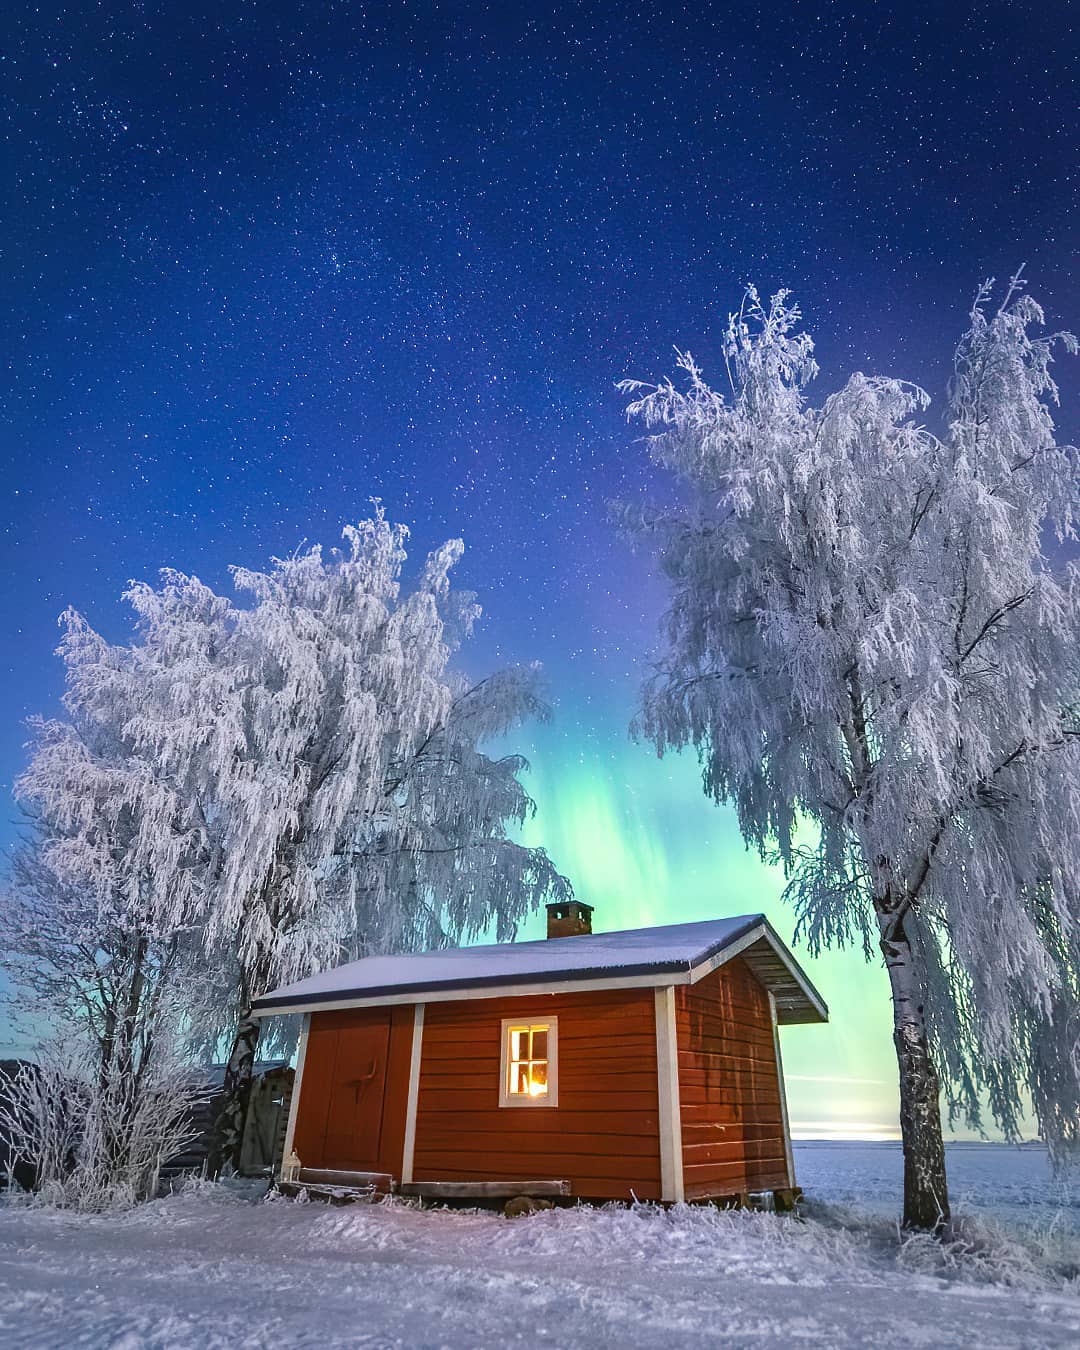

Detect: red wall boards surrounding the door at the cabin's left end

[293,1004,413,1177]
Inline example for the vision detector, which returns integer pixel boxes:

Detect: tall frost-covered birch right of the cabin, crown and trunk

[621,279,1080,1229]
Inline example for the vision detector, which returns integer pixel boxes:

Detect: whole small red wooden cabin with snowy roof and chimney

[255,902,828,1202]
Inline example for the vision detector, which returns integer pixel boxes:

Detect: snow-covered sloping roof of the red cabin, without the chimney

[252,914,829,1022]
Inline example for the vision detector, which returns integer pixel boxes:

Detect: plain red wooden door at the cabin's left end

[323,1008,390,1172]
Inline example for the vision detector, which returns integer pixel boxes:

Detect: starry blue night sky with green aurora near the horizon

[0,0,1080,1134]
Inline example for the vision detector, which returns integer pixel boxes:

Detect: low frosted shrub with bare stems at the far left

[0,1042,208,1211]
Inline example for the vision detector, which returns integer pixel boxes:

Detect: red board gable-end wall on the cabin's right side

[675,957,788,1200]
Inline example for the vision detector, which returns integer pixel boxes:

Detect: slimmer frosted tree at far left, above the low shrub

[5,612,207,1075]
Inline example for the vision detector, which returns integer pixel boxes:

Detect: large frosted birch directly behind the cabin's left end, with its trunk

[58,510,568,1157]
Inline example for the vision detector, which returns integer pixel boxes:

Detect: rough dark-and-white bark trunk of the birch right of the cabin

[880,915,949,1231]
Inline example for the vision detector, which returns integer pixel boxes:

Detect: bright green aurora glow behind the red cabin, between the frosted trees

[510,717,923,1139]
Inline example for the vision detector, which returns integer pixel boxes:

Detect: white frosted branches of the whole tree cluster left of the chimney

[14,509,570,1166]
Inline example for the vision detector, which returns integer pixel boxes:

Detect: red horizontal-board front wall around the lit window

[413,988,660,1200]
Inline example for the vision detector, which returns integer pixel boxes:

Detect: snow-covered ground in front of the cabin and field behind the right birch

[0,1143,1080,1350]
